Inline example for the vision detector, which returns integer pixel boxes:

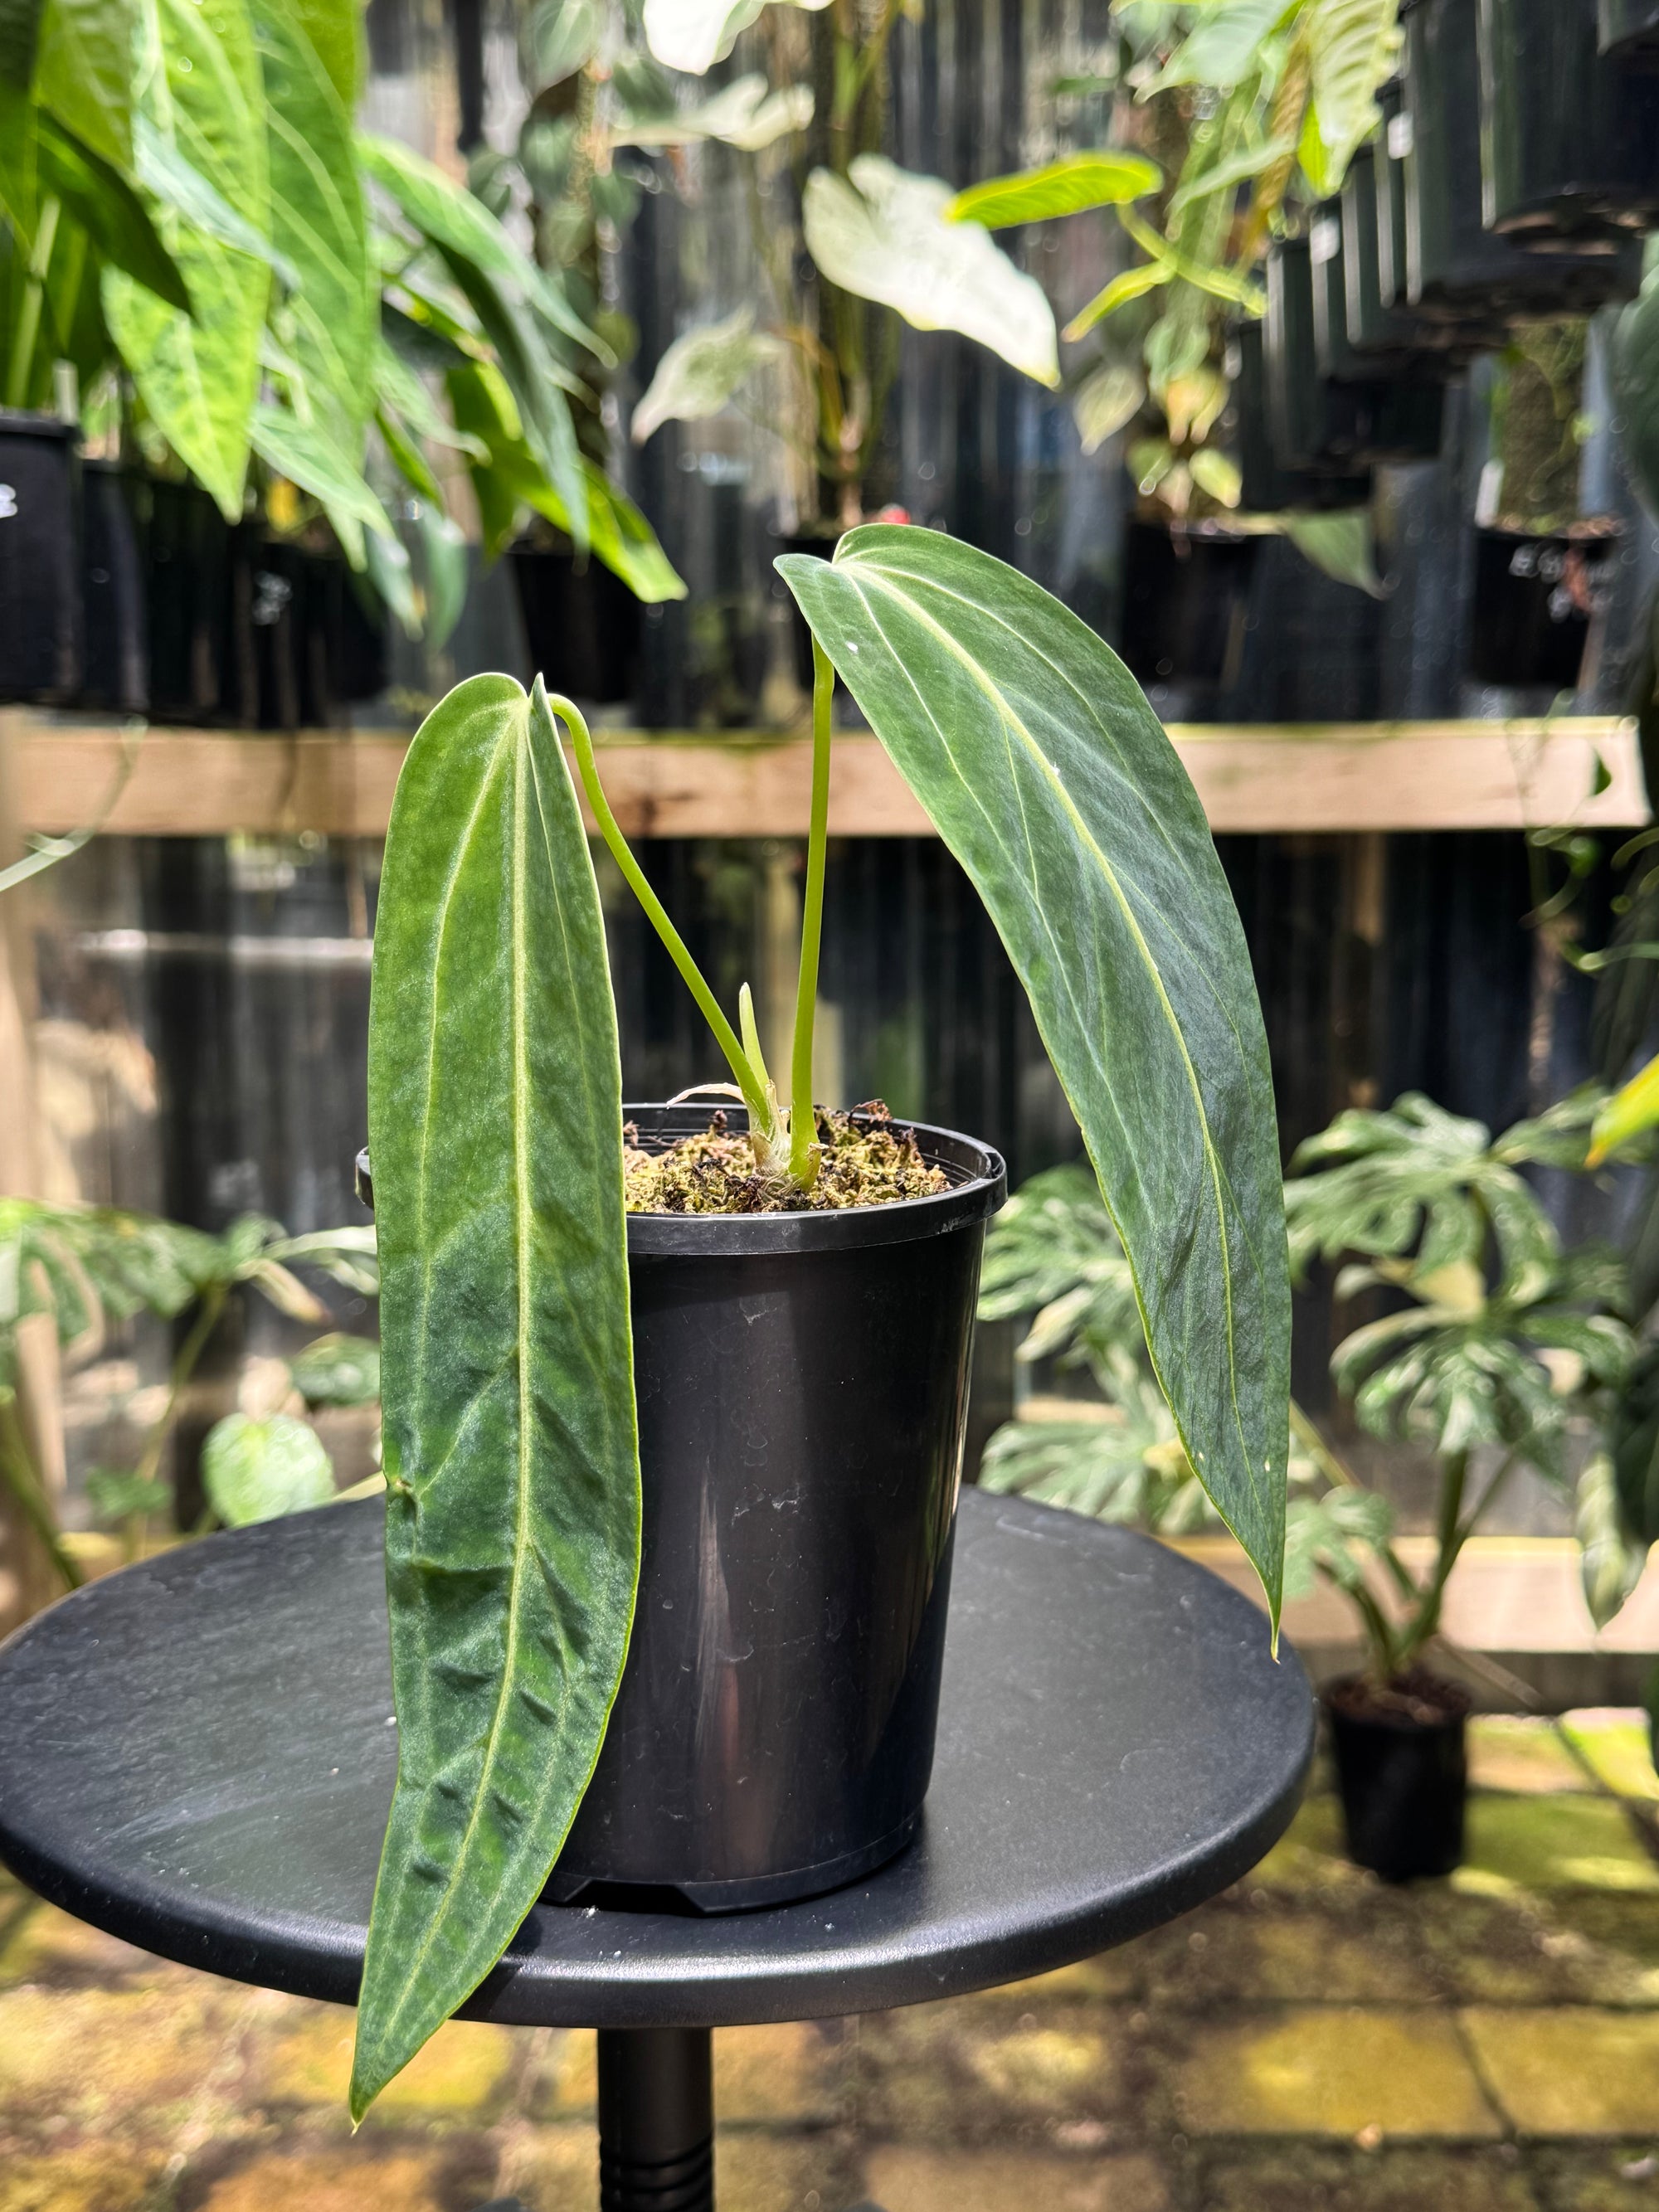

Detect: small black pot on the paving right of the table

[1321,1684,1469,1883]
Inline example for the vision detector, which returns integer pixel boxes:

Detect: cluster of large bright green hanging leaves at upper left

[0,0,684,641]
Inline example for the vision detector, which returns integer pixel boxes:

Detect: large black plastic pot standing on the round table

[358,1106,1006,1911]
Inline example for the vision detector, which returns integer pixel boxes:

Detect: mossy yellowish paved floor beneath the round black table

[0,1714,1659,2212]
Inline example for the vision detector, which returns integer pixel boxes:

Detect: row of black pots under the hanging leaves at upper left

[0,414,387,730]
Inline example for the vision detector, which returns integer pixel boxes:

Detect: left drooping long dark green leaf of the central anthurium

[352,677,640,2115]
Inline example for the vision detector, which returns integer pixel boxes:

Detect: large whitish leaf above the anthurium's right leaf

[800,153,1059,385]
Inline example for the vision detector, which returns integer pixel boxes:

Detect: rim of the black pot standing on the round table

[356,1101,1009,1259]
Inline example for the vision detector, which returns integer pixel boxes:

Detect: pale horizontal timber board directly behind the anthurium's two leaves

[0,710,1648,839]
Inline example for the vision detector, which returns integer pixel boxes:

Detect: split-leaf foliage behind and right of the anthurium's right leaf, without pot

[980,1091,1659,1681]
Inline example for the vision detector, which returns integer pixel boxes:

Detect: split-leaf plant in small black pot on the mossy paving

[1285,1095,1646,1880]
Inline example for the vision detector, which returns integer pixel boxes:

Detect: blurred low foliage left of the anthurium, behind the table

[0,1199,381,1588]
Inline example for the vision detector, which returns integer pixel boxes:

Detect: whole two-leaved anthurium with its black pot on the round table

[352,524,1290,2112]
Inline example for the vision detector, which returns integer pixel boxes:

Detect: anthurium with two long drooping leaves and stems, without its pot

[352,524,1290,2112]
